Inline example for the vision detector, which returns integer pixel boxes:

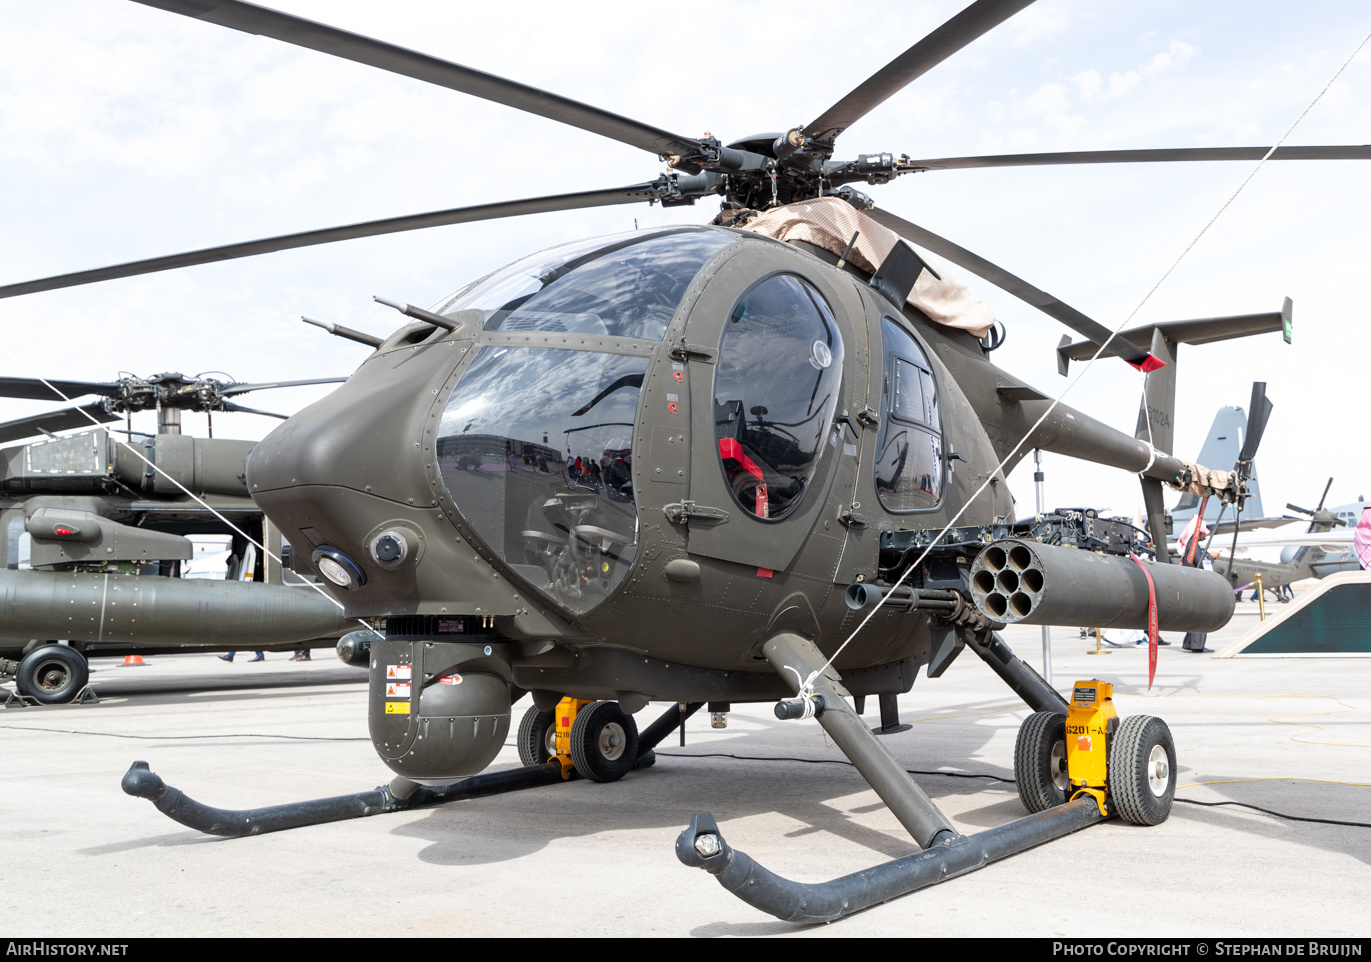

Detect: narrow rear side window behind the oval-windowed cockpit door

[876,318,943,511]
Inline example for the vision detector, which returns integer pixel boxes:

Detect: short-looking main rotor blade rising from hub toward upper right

[805,0,1034,143]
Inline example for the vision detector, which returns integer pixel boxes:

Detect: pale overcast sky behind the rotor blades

[0,0,1371,526]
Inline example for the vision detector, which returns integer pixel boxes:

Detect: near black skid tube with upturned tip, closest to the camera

[676,798,1101,924]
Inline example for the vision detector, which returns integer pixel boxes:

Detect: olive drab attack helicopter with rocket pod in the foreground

[0,0,1371,921]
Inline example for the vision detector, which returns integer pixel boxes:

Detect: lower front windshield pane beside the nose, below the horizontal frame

[437,347,648,614]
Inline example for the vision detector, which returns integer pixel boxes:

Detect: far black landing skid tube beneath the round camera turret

[122,702,703,839]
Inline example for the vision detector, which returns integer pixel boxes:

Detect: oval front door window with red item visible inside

[714,274,843,519]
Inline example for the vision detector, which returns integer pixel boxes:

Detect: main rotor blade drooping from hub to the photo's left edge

[0,184,654,297]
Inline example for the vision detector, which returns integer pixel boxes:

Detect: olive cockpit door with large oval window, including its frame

[677,241,865,571]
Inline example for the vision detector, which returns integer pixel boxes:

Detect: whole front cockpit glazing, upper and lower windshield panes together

[435,227,736,614]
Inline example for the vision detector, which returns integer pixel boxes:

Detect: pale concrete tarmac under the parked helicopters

[0,603,1371,939]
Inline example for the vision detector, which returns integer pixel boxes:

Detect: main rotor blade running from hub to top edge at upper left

[134,0,699,161]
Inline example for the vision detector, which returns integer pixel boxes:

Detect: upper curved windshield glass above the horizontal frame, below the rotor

[435,227,733,341]
